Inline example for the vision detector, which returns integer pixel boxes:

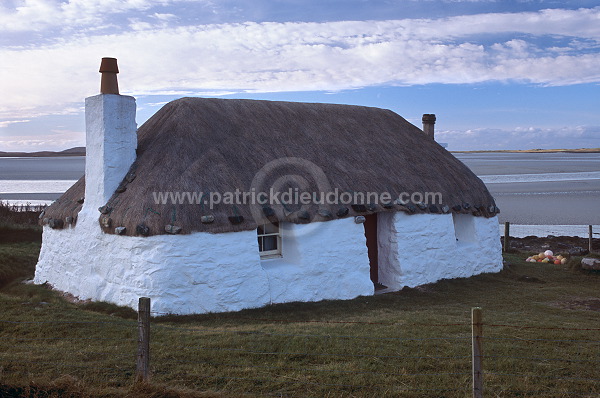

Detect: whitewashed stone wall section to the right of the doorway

[378,212,502,290]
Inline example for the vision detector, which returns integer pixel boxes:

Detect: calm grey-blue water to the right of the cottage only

[455,153,600,229]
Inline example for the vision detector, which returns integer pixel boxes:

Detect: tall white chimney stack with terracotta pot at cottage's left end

[85,58,137,209]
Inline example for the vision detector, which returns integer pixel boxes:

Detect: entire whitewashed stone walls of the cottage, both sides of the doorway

[35,208,502,314]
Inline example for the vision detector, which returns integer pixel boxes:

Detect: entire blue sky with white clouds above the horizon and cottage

[0,0,600,152]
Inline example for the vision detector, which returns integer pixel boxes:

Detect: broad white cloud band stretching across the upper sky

[0,7,600,118]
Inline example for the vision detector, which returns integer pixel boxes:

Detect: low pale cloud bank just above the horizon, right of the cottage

[436,126,600,151]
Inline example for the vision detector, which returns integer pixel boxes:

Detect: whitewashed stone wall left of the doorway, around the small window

[35,208,373,314]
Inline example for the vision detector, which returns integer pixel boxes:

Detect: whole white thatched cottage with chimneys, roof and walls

[35,59,502,314]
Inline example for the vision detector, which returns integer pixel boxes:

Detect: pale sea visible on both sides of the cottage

[0,152,600,237]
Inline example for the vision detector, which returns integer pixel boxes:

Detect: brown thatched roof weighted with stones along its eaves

[44,98,498,235]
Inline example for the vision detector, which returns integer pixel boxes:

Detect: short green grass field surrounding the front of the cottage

[0,222,600,397]
